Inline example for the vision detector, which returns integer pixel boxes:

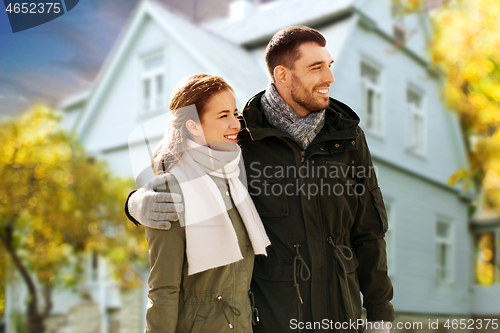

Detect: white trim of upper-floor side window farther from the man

[405,85,427,156]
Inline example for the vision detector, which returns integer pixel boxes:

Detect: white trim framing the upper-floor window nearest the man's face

[359,56,384,137]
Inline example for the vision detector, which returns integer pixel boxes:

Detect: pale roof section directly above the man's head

[204,0,356,45]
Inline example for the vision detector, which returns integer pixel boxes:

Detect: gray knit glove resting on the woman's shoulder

[127,173,184,230]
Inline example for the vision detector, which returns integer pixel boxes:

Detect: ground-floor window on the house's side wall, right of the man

[436,219,453,283]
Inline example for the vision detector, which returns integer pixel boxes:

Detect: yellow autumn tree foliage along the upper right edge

[431,0,500,210]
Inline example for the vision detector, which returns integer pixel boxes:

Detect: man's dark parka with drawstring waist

[238,92,394,333]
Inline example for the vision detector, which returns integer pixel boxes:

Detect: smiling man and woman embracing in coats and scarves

[126,27,394,333]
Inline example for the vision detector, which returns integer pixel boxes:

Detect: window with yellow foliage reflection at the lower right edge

[475,231,500,286]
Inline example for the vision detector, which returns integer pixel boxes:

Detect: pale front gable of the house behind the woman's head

[72,1,267,151]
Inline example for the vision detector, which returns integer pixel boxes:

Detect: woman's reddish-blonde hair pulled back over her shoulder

[151,74,234,175]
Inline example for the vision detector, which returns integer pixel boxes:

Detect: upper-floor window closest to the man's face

[361,60,382,134]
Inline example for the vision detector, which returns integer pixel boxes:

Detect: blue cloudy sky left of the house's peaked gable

[0,0,228,119]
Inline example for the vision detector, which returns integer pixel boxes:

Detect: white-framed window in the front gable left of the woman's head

[141,52,165,112]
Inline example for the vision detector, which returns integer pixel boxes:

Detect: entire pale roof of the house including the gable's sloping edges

[62,0,356,138]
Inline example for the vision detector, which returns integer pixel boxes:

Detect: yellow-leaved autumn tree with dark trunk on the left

[0,106,147,333]
